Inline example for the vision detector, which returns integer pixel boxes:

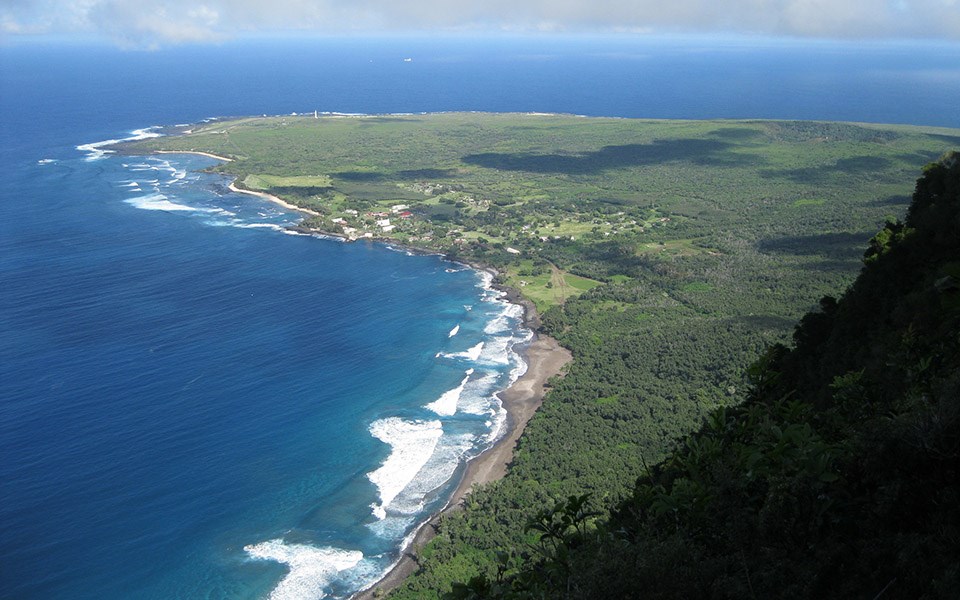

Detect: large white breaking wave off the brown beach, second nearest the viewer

[367,417,443,519]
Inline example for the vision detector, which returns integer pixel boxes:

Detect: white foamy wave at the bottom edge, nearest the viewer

[243,540,363,600]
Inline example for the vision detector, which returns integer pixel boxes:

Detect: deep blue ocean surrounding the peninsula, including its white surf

[0,38,960,599]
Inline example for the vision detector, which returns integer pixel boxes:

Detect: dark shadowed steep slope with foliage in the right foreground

[451,153,960,598]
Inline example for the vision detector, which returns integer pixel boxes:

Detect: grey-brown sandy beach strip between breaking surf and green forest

[351,328,573,600]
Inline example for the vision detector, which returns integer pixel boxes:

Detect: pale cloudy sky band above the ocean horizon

[0,0,960,46]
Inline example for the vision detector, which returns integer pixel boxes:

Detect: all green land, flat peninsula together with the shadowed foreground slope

[127,114,960,598]
